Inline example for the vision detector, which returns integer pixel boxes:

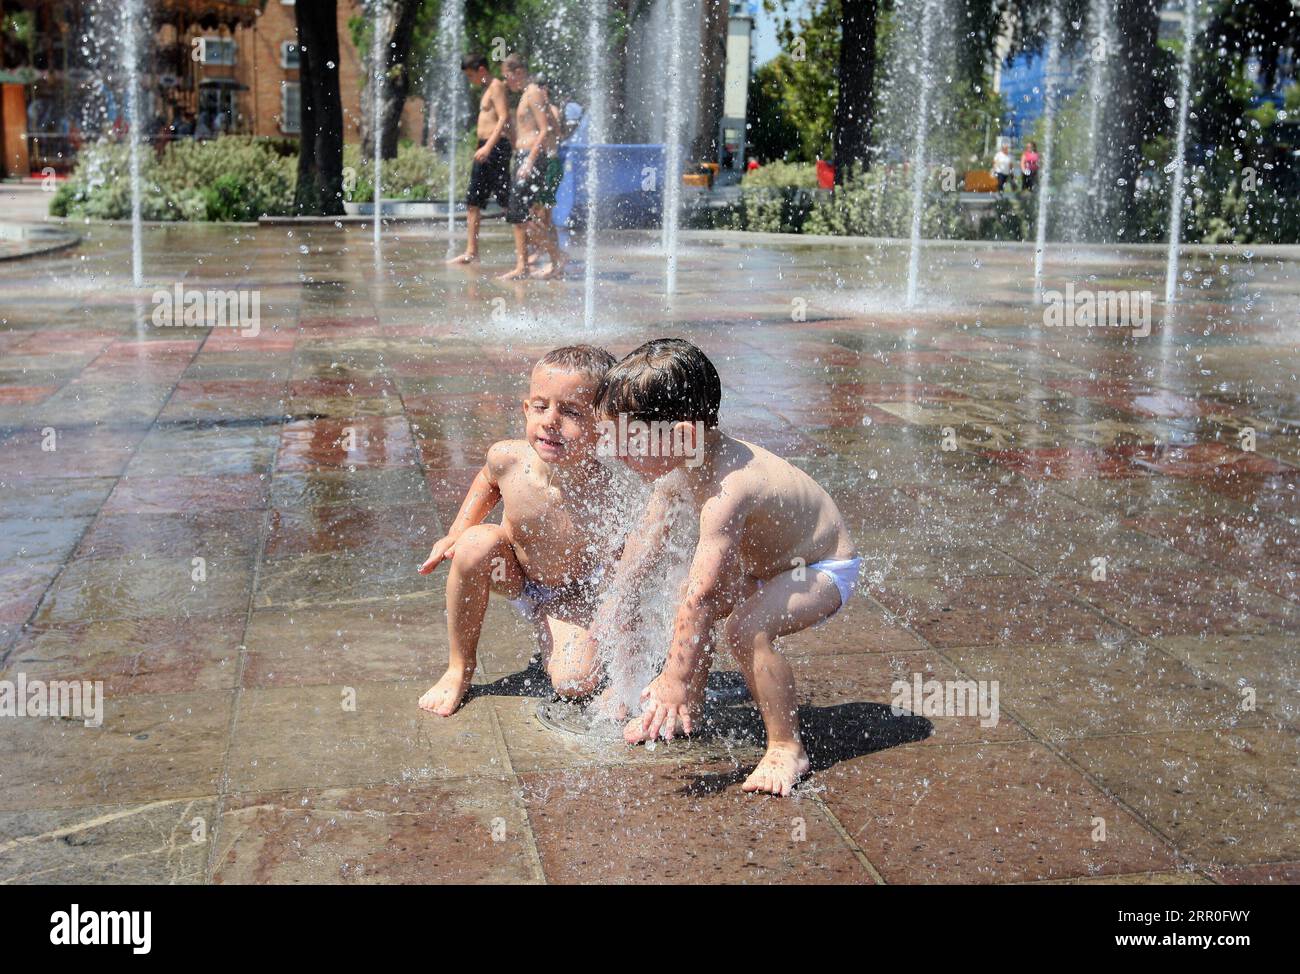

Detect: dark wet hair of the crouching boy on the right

[595,338,723,429]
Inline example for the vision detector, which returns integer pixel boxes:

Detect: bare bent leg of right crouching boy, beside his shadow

[722,568,840,795]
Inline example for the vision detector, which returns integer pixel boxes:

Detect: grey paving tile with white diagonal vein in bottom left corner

[0,797,216,886]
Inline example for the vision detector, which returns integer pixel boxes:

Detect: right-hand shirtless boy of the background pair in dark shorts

[501,55,564,281]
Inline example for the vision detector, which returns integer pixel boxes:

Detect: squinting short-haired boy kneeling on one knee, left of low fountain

[420,345,618,717]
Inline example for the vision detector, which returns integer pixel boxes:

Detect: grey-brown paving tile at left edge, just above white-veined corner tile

[0,691,233,811]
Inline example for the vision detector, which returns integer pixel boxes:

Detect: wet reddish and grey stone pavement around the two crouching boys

[0,226,1300,883]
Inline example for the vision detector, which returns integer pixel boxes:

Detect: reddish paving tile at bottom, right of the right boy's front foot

[813,743,1175,883]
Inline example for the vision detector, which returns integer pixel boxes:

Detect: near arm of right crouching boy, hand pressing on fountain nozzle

[641,497,745,740]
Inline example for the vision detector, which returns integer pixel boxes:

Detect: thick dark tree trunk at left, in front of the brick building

[294,0,343,216]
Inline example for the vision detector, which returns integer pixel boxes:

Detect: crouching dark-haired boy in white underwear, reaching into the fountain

[589,338,862,795]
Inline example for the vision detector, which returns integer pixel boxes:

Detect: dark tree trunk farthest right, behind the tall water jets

[1101,0,1162,229]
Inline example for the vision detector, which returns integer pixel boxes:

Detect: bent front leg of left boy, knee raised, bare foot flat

[420,524,524,717]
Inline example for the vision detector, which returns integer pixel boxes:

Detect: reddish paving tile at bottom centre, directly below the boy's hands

[520,765,875,884]
